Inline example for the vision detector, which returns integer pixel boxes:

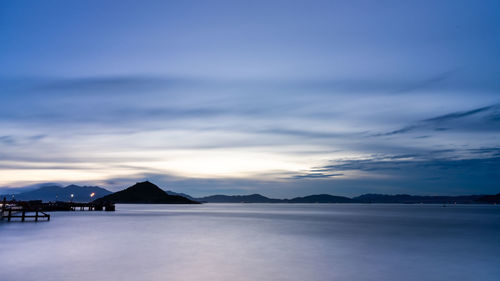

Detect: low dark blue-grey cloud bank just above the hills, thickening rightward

[62,148,500,198]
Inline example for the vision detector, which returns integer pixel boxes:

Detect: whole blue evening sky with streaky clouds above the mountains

[0,0,500,198]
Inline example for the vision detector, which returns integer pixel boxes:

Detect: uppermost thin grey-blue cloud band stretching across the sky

[0,69,488,96]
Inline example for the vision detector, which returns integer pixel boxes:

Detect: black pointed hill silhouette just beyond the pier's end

[94,181,200,204]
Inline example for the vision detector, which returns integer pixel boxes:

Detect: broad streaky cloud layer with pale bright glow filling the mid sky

[0,73,498,195]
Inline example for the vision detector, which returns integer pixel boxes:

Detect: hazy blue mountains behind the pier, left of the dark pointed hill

[0,184,112,202]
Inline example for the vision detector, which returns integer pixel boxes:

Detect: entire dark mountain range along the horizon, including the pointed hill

[0,181,500,204]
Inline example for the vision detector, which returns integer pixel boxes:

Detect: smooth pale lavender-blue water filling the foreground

[0,204,500,281]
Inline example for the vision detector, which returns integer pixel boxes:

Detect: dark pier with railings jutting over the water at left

[0,198,115,222]
